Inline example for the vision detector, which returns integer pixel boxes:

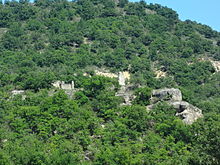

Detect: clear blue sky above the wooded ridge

[131,0,220,32]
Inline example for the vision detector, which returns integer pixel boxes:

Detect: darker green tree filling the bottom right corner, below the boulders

[191,113,220,164]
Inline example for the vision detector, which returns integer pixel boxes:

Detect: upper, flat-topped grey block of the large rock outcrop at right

[151,88,182,103]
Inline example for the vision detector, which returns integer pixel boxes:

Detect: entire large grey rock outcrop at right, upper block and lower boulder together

[147,88,203,124]
